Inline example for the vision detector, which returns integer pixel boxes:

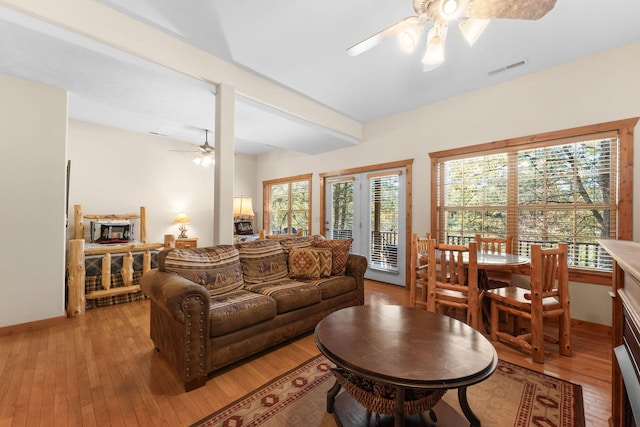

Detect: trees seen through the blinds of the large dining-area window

[437,137,617,269]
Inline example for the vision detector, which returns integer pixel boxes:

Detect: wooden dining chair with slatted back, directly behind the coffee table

[427,239,482,330]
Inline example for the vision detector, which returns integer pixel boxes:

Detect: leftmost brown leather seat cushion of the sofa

[209,289,277,337]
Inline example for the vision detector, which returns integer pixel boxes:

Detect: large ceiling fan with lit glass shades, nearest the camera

[347,0,556,71]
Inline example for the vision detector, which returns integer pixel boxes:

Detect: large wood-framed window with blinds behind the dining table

[431,119,637,281]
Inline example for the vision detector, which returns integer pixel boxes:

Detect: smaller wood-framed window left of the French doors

[262,174,311,235]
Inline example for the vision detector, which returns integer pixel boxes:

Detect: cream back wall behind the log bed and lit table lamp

[69,120,259,247]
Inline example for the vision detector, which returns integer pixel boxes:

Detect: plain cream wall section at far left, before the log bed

[0,75,67,327]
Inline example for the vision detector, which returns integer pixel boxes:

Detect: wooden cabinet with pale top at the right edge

[598,240,640,427]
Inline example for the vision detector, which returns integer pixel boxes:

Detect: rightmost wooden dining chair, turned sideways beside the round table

[485,243,571,363]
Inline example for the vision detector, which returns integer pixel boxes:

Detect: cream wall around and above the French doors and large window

[257,42,640,325]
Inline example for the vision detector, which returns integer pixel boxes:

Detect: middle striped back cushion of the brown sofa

[239,240,288,284]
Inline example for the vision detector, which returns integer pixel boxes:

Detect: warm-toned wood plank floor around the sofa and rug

[0,282,611,427]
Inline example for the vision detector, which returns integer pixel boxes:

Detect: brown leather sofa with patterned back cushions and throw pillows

[140,237,367,391]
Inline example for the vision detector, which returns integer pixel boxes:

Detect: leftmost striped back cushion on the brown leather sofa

[158,245,243,295]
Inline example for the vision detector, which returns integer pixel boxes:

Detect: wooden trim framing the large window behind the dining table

[429,117,639,285]
